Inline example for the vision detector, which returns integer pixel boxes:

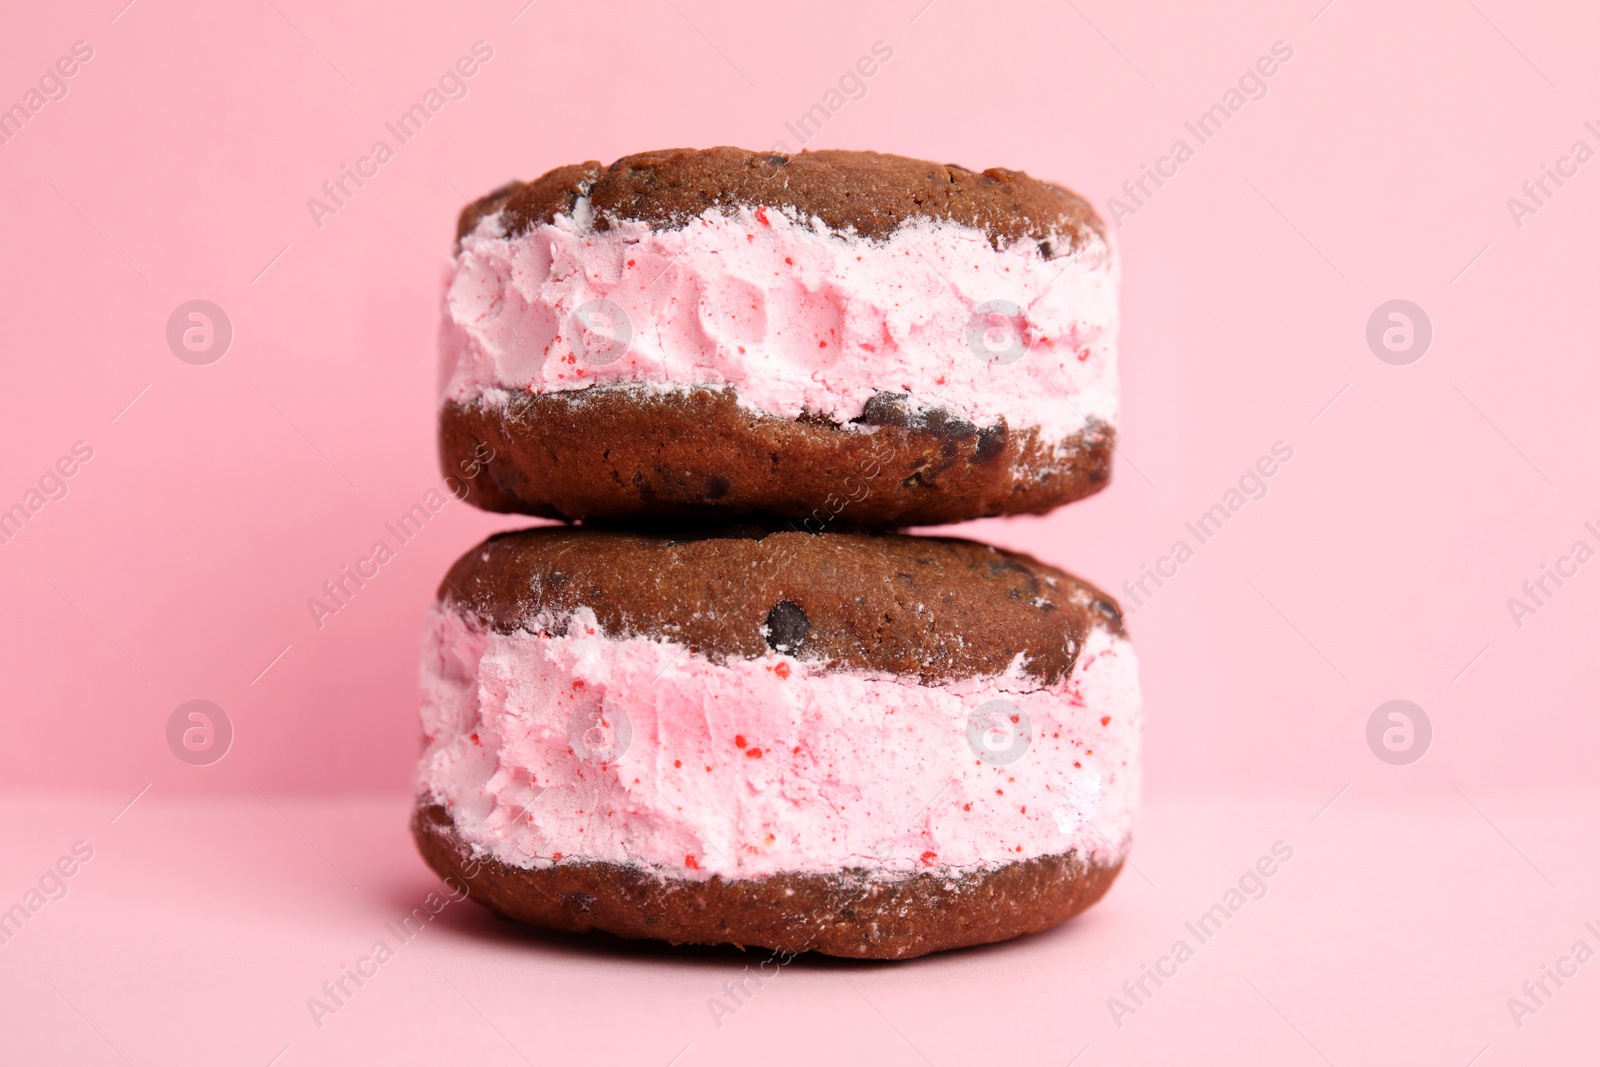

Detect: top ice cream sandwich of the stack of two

[440,149,1117,530]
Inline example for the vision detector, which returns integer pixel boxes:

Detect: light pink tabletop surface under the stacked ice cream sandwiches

[0,787,1600,1067]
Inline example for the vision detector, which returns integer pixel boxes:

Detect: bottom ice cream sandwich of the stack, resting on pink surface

[414,528,1141,958]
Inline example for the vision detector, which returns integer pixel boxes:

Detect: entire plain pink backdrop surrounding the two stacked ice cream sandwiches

[0,0,1600,1064]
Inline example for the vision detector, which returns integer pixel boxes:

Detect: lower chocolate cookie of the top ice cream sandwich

[440,387,1115,531]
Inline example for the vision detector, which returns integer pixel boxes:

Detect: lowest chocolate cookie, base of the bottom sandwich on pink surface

[411,805,1122,960]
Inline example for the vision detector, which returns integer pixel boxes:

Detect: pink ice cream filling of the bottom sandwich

[418,606,1142,880]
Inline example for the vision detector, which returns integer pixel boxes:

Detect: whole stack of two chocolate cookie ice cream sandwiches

[414,149,1141,958]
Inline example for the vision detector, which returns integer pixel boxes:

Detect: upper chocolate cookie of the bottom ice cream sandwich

[438,526,1123,686]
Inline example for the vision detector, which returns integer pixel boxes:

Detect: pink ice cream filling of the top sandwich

[442,198,1117,442]
